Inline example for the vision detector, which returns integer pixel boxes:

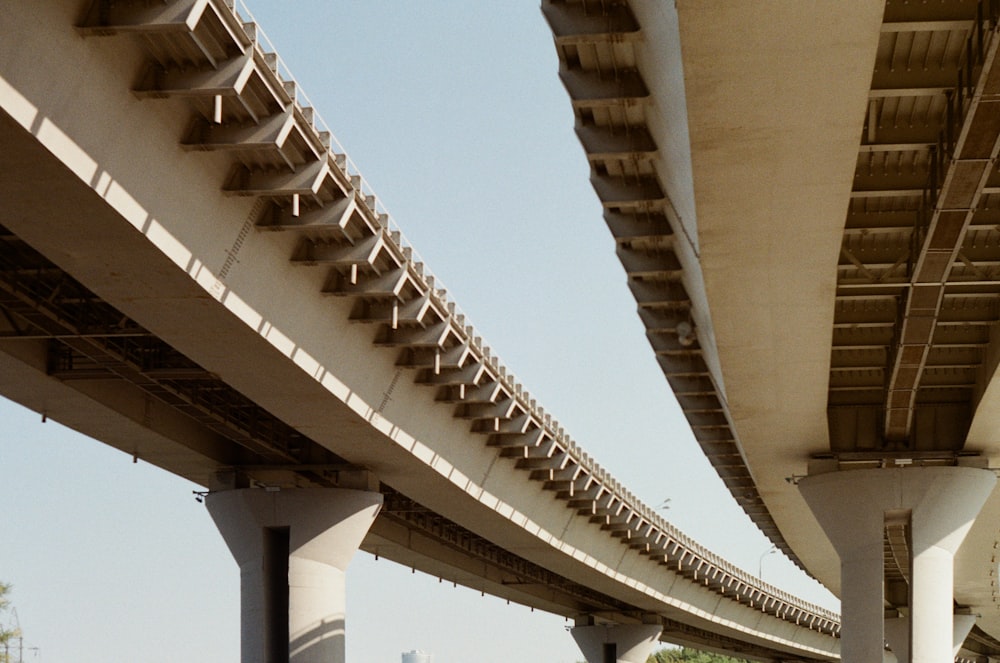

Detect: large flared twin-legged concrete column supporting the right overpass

[799,467,996,663]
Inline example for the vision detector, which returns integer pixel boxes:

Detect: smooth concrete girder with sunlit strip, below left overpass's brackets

[0,0,836,660]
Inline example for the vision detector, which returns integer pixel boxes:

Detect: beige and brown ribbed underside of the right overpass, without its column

[679,1,1000,651]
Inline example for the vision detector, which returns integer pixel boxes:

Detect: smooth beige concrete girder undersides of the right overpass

[584,0,1000,652]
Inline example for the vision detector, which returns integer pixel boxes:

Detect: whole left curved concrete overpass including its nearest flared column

[0,1,838,661]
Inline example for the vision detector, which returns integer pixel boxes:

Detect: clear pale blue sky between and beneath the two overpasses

[0,0,836,663]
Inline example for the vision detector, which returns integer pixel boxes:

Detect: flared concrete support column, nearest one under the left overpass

[205,488,382,663]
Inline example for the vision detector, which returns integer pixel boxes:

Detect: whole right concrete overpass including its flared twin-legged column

[544,0,1000,661]
